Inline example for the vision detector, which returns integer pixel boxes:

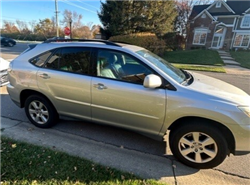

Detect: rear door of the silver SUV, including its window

[36,47,91,119]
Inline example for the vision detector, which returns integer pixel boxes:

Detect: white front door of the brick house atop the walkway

[212,26,226,49]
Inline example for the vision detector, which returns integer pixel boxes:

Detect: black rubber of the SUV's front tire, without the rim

[170,123,228,169]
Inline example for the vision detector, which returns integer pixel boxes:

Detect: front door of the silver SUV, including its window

[91,50,166,135]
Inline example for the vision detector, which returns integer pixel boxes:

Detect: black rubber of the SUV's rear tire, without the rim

[24,95,58,128]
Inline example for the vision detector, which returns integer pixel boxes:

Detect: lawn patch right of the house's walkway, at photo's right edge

[230,51,250,69]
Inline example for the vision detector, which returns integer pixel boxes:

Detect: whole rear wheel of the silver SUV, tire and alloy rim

[24,95,58,128]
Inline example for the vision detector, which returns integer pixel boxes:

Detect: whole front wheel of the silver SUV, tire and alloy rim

[170,123,228,169]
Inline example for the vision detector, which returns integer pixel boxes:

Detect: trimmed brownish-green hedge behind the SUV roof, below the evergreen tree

[109,33,167,55]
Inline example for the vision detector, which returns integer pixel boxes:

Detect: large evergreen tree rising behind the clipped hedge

[98,0,177,36]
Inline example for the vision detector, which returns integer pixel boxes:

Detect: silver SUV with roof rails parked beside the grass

[7,39,250,168]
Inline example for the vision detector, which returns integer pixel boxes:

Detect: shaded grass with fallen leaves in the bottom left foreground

[0,136,163,185]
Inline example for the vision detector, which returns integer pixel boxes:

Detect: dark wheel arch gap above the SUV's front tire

[168,116,235,154]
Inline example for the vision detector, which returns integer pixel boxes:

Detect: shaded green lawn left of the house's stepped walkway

[163,50,224,66]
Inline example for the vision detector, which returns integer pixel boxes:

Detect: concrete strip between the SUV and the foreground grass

[0,117,250,185]
